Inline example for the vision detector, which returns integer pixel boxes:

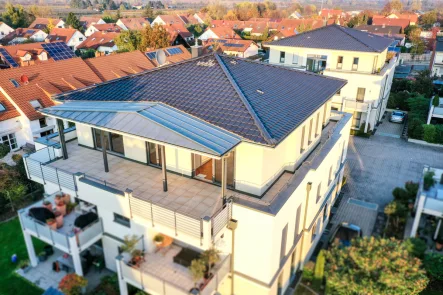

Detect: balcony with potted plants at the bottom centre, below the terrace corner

[117,244,230,295]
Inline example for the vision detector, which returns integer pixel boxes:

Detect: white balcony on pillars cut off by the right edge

[410,166,443,240]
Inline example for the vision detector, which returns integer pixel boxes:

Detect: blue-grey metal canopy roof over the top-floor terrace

[39,101,241,158]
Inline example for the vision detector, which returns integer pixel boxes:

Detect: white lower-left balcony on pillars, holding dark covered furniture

[19,194,103,253]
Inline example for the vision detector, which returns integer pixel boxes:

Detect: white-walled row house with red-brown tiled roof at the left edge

[0,58,101,148]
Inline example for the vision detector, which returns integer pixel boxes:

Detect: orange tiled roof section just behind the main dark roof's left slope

[84,50,154,82]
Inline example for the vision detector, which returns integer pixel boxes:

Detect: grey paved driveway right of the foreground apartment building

[331,136,443,235]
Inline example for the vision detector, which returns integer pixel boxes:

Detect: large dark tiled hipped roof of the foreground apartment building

[54,54,346,145]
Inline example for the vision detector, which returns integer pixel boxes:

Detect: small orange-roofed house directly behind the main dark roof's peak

[206,39,258,58]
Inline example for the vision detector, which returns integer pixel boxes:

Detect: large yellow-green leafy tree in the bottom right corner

[326,237,429,295]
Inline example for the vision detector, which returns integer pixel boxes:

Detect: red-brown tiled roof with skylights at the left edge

[0,58,101,121]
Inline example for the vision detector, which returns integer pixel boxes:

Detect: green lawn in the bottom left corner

[0,218,44,295]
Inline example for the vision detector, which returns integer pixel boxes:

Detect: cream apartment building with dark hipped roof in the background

[268,25,396,131]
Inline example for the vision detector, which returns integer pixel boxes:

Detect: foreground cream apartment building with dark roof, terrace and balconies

[19,54,351,295]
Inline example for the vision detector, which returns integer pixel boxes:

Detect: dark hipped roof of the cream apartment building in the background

[268,25,392,52]
